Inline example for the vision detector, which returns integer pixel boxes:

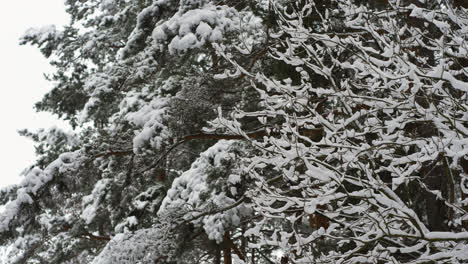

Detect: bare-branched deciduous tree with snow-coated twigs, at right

[212,0,468,263]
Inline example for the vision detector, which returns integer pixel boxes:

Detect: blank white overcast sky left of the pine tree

[0,0,68,187]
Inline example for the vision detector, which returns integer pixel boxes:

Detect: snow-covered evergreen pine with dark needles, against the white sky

[0,0,266,263]
